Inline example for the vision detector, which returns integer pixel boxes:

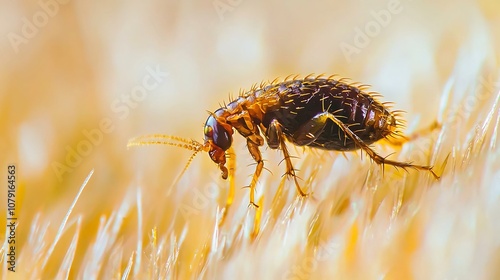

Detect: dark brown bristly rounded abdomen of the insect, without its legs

[254,79,397,151]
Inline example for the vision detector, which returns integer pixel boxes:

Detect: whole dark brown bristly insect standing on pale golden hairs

[129,77,438,223]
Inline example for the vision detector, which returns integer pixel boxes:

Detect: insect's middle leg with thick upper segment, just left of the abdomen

[267,120,307,196]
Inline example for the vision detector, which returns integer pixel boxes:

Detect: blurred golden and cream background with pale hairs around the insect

[0,0,500,279]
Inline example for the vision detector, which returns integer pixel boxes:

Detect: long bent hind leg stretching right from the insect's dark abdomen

[294,112,439,179]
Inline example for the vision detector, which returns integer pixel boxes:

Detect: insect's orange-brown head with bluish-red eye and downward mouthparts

[203,111,233,179]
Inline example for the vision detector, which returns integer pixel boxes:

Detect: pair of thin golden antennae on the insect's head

[127,134,208,192]
